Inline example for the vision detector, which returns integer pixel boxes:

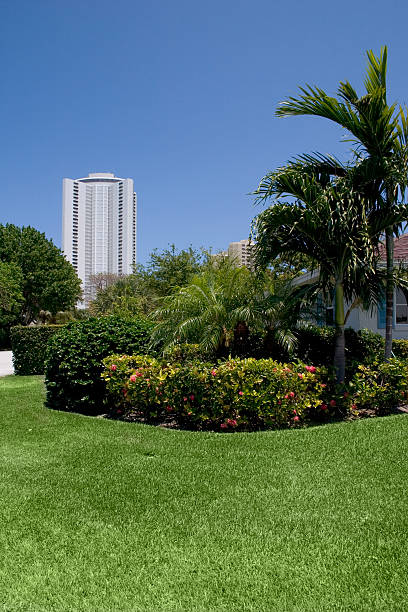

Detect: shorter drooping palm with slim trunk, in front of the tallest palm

[253,166,408,383]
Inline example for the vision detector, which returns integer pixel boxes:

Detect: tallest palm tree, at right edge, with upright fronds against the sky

[276,47,408,359]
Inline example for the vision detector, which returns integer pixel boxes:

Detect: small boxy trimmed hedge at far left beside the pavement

[10,325,64,376]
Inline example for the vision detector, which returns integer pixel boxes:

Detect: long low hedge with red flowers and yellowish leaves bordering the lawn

[102,355,336,431]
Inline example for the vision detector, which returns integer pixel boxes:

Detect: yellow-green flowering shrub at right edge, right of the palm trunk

[348,359,408,414]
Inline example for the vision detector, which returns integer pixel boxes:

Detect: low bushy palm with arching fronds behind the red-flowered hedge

[152,259,295,355]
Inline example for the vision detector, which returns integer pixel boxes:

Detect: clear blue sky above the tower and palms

[0,0,408,262]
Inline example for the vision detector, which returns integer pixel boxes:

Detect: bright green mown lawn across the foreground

[0,376,408,612]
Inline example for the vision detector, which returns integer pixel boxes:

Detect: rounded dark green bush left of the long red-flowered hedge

[45,316,152,414]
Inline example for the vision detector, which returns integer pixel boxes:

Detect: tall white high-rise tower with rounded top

[62,172,137,305]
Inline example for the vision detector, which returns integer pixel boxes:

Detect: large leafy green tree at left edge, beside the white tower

[0,224,81,325]
